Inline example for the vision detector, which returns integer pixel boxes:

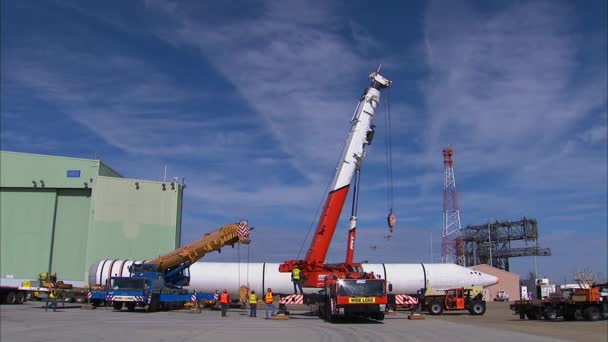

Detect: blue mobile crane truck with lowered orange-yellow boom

[89,220,250,312]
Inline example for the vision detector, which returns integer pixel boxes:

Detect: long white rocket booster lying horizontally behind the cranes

[89,260,500,294]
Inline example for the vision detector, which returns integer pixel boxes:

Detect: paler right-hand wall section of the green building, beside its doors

[87,176,182,276]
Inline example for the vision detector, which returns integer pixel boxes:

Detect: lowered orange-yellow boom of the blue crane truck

[146,220,250,272]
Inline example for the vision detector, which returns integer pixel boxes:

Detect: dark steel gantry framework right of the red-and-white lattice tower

[462,217,551,271]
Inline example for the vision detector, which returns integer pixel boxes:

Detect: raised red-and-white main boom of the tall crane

[279,68,391,287]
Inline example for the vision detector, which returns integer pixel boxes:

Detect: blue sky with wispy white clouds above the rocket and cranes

[0,0,608,281]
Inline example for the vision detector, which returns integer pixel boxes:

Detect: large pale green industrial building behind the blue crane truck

[0,151,183,284]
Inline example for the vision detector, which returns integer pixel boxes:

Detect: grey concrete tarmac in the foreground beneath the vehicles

[0,302,585,342]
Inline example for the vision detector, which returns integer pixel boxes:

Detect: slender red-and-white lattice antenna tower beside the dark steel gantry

[441,145,465,266]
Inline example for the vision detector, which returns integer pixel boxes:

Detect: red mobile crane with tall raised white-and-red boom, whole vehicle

[279,67,391,321]
